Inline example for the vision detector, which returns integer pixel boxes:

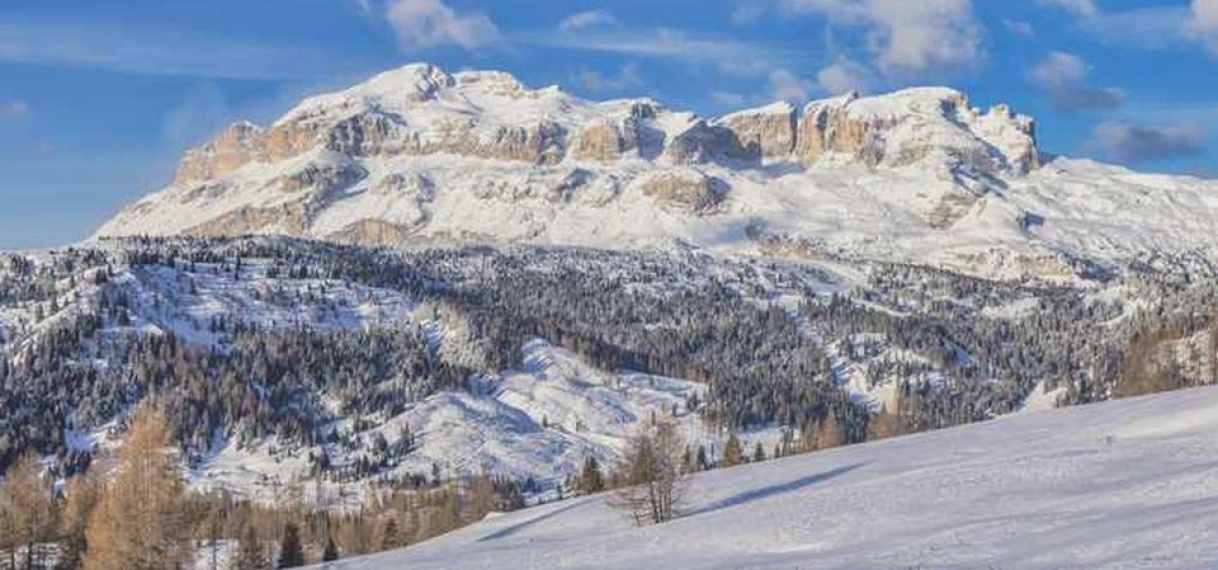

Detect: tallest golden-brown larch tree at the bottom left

[83,408,192,570]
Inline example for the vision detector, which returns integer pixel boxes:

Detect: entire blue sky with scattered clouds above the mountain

[0,0,1218,248]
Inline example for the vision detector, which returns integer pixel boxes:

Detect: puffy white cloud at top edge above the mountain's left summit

[385,0,502,51]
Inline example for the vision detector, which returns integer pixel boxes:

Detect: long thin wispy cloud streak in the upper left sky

[0,21,367,80]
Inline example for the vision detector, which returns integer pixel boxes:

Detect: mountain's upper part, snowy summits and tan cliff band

[161,65,1038,185]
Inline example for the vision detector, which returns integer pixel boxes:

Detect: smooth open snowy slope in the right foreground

[309,389,1218,570]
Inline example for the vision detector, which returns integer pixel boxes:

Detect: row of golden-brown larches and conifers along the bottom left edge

[0,407,524,570]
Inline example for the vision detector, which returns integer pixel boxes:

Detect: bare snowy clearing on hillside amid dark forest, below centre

[192,341,780,504]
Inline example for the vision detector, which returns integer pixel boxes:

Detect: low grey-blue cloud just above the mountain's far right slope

[1086,122,1206,162]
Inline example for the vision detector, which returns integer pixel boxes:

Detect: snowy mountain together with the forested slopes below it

[0,65,1218,516]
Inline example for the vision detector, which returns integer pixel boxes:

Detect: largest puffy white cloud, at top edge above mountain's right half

[782,0,985,76]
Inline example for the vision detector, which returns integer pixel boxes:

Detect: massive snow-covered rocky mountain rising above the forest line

[96,65,1218,276]
